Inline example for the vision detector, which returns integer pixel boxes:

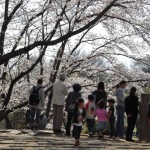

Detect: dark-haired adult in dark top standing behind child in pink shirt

[92,82,107,108]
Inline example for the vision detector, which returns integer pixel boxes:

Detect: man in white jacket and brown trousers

[52,73,68,133]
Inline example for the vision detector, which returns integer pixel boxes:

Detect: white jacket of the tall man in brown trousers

[52,80,68,106]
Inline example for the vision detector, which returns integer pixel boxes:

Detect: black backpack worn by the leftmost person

[29,86,42,106]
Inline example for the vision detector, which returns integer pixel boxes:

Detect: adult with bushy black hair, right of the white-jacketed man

[65,84,81,136]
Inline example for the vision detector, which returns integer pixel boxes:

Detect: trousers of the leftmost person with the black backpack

[30,108,41,125]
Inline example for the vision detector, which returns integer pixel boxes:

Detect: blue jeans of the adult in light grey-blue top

[116,105,124,137]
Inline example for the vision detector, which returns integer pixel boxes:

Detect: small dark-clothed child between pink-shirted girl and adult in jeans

[108,99,117,138]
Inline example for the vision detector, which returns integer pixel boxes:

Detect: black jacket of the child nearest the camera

[72,108,86,123]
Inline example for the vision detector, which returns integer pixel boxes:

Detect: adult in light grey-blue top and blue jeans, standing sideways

[116,81,127,138]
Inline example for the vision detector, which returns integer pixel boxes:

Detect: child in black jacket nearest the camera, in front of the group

[73,98,85,146]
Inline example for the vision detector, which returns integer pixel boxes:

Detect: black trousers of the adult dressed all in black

[126,115,137,140]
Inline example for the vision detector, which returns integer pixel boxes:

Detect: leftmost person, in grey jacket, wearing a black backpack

[29,78,45,130]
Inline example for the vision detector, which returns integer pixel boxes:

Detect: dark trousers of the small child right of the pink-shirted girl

[109,117,117,137]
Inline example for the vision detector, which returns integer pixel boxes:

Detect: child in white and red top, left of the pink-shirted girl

[85,94,96,138]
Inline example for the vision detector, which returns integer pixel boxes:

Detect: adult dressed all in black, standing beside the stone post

[125,87,139,142]
